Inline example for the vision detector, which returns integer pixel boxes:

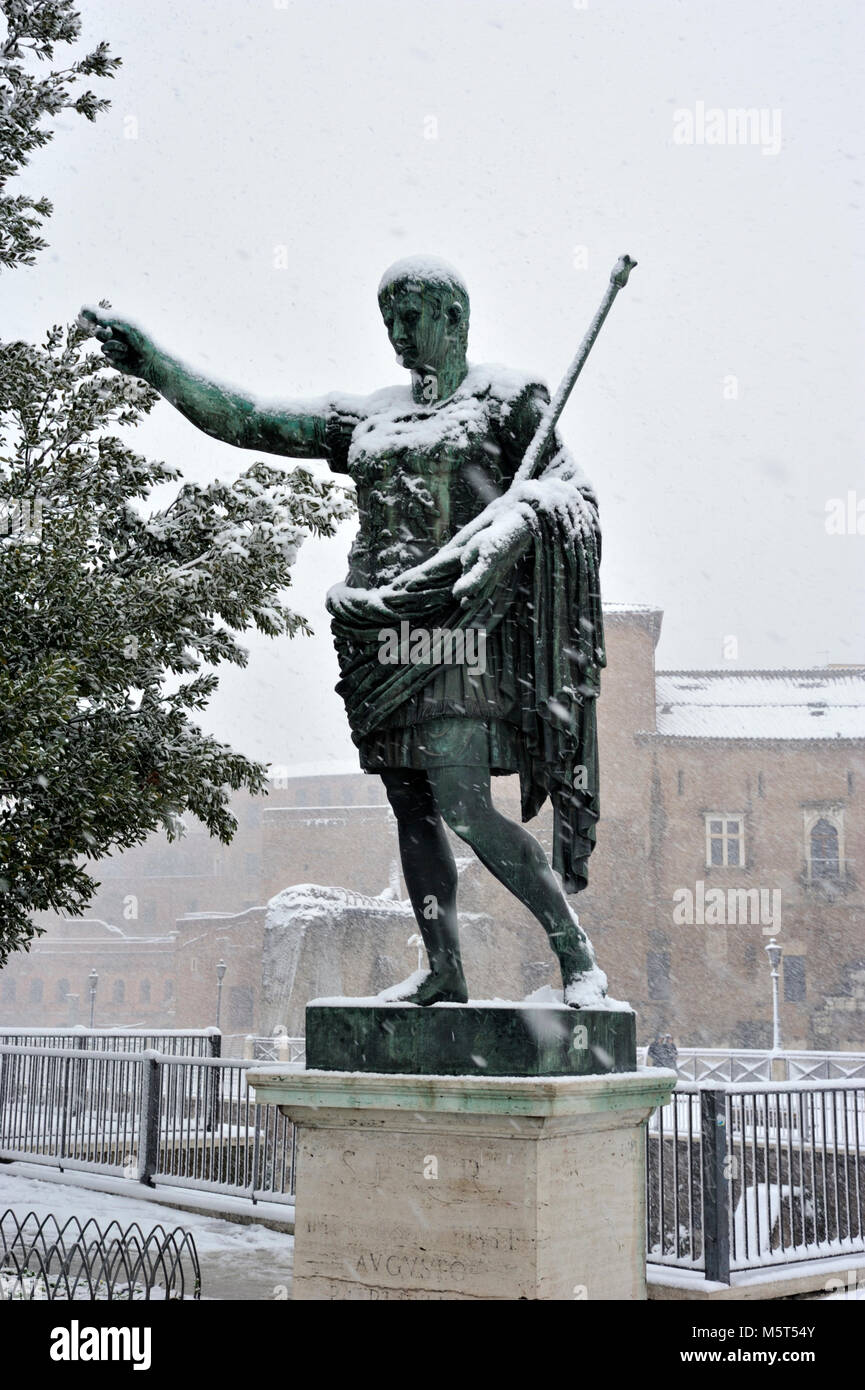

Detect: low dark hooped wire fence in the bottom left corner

[0,1209,202,1302]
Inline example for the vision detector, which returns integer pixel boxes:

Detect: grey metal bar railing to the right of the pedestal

[647,1080,865,1283]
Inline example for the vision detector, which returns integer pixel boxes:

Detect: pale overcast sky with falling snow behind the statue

[0,0,865,763]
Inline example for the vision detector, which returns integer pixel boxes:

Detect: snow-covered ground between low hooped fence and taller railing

[0,1166,295,1300]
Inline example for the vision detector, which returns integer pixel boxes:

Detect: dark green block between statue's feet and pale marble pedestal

[306,1004,637,1076]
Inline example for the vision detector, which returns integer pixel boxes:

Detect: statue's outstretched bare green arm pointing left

[81,309,328,459]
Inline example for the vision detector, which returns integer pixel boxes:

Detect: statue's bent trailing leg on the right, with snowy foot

[428,767,606,1005]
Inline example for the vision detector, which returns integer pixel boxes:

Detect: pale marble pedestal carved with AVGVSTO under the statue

[248,1066,676,1300]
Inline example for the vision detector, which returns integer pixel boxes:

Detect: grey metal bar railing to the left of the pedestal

[0,1045,295,1202]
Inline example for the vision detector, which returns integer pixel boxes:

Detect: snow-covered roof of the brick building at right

[655,666,865,739]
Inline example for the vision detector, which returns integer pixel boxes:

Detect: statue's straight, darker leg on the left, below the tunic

[381,767,469,1004]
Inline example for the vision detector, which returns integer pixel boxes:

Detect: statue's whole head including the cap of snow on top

[378,256,469,386]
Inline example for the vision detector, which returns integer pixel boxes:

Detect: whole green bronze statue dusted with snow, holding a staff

[83,257,633,1008]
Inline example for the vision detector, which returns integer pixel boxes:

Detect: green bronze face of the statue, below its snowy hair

[380,282,467,373]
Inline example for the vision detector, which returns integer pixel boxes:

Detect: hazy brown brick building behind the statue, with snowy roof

[0,605,865,1048]
